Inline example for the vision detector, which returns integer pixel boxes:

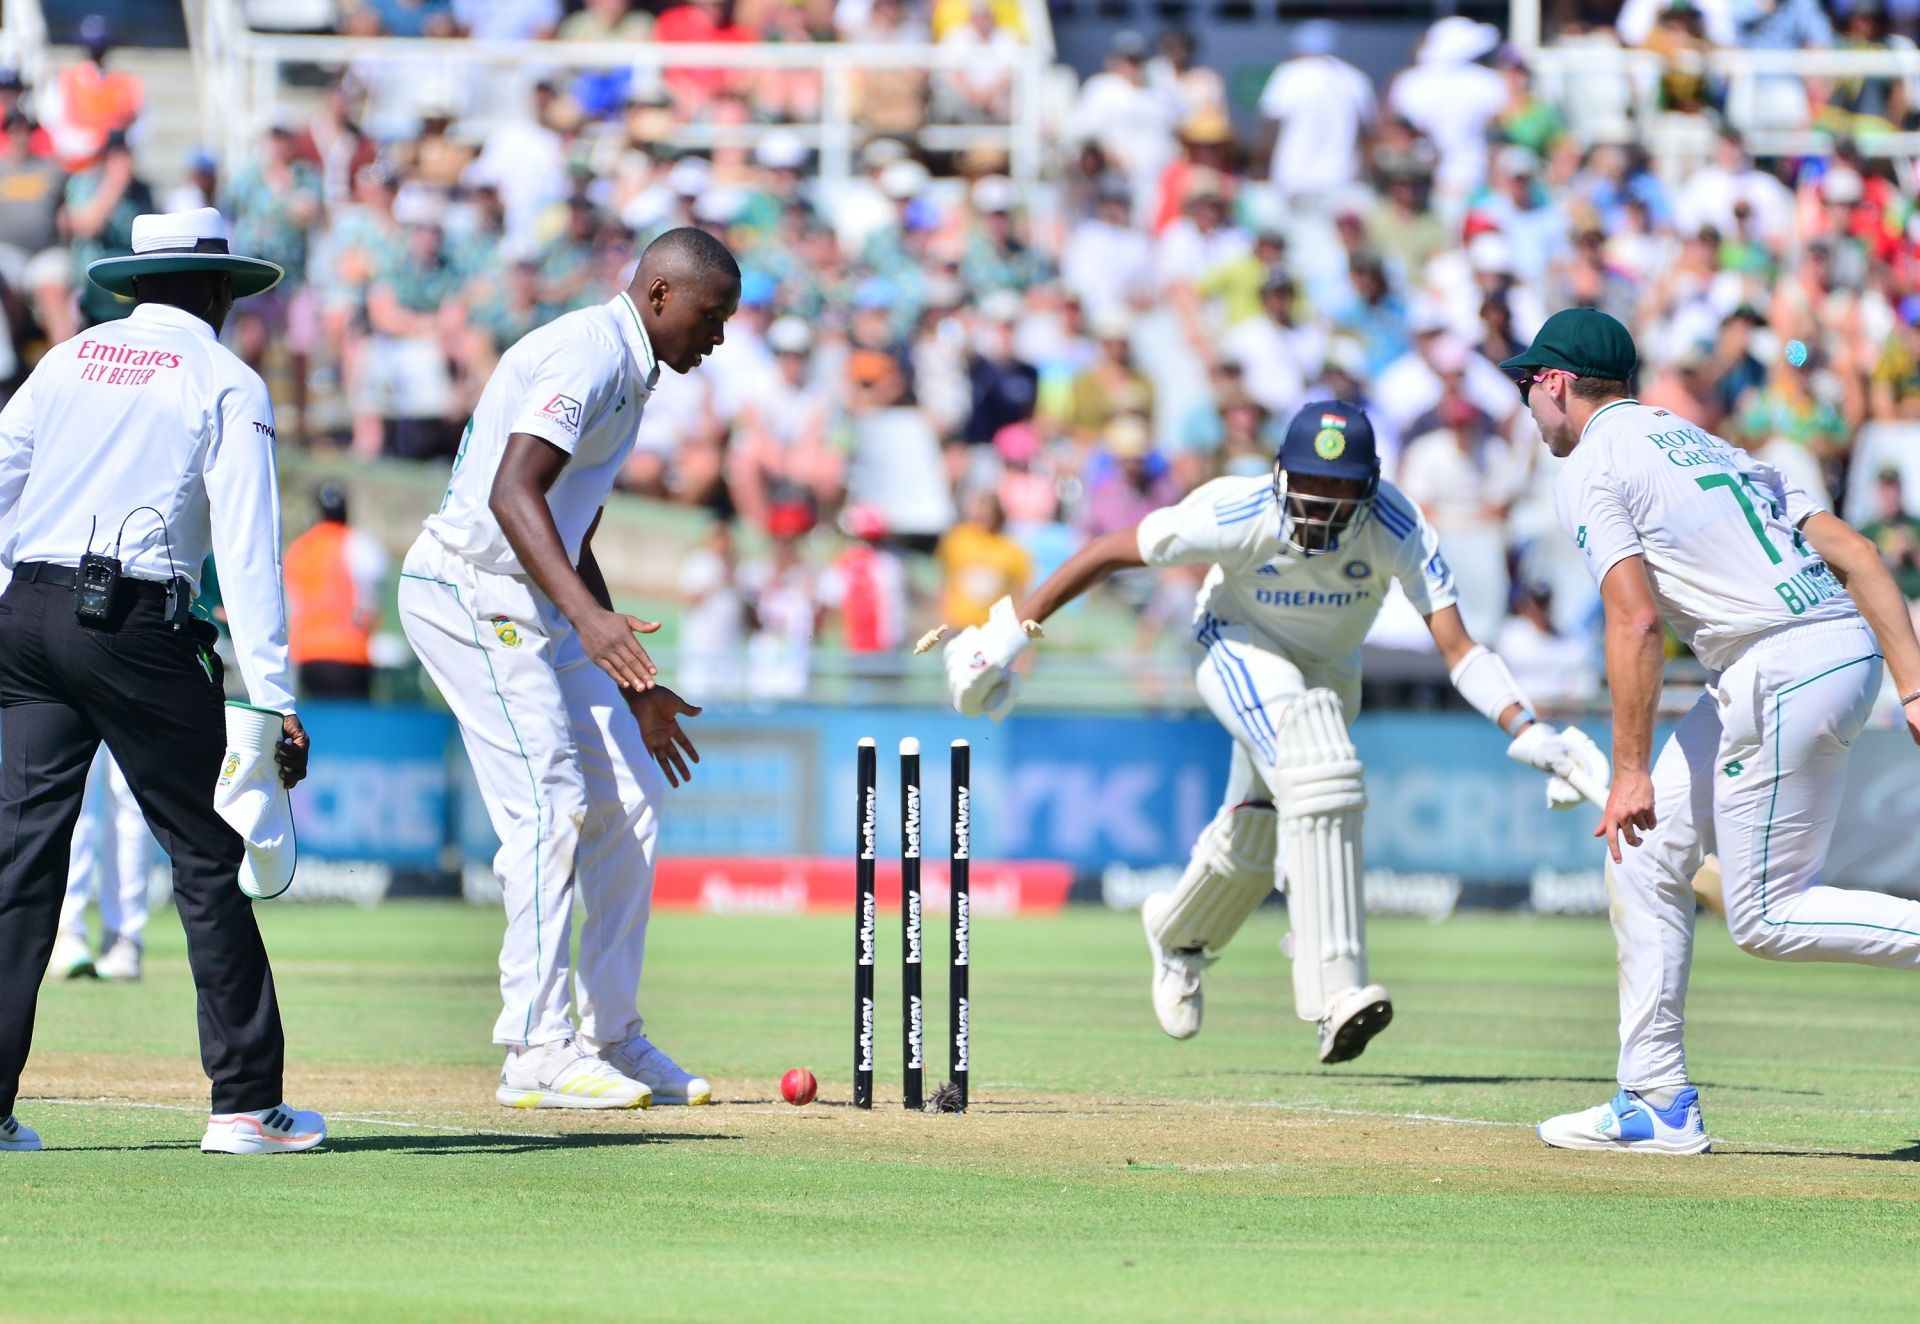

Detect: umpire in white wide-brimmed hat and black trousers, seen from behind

[0,207,326,1153]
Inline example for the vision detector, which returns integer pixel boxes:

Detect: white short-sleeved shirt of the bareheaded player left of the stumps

[426,294,660,576]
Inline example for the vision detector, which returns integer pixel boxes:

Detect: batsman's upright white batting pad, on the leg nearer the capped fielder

[1275,689,1367,1021]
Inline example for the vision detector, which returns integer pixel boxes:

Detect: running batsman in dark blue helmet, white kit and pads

[945,401,1607,1063]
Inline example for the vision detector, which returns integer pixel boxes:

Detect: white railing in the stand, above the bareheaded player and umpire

[188,0,1052,186]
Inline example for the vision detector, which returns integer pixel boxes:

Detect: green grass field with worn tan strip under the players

[0,904,1920,1324]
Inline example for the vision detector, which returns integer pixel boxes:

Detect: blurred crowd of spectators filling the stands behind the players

[0,0,1920,700]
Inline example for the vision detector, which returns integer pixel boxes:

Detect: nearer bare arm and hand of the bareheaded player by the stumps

[488,432,660,691]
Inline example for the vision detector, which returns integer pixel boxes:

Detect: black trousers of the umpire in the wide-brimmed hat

[0,579,286,1117]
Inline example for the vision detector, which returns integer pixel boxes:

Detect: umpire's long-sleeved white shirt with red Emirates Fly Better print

[0,303,294,712]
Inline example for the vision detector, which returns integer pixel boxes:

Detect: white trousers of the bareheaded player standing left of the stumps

[399,533,666,1046]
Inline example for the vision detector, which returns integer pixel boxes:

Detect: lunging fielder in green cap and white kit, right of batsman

[1528,309,1920,1153]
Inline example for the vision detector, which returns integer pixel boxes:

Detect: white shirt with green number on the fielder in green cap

[1553,399,1859,672]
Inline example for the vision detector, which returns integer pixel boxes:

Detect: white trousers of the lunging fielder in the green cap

[1607,620,1920,1090]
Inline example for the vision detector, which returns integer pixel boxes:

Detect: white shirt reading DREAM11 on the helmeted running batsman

[1140,474,1453,666]
